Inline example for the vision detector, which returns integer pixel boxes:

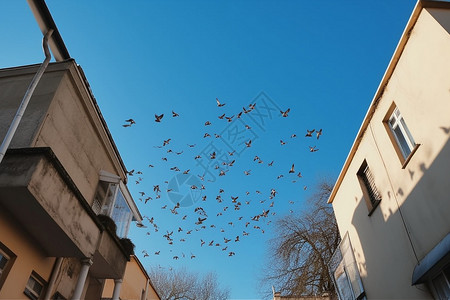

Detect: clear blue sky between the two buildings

[0,0,415,299]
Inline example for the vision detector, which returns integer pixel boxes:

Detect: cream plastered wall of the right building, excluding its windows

[333,5,450,299]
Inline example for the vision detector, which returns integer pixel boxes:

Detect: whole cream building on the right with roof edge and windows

[329,1,450,299]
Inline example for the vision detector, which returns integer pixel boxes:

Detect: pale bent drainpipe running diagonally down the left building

[0,29,53,163]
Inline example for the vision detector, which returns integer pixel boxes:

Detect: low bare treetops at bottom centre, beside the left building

[149,267,229,300]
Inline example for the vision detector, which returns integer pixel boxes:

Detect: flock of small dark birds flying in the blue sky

[122,98,322,260]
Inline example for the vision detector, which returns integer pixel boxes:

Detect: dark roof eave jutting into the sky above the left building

[27,0,70,61]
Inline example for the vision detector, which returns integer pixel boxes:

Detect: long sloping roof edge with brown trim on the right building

[328,0,450,203]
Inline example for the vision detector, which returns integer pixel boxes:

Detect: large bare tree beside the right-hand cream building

[262,180,340,298]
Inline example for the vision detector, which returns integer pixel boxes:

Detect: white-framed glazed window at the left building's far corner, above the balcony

[92,171,133,238]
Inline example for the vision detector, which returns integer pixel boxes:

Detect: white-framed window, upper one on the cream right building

[387,105,416,162]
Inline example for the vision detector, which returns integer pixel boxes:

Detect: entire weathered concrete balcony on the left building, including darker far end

[0,148,128,278]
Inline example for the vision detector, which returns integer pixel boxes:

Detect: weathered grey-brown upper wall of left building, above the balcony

[0,61,125,207]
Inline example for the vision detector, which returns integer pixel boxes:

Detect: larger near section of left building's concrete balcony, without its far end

[0,150,100,257]
